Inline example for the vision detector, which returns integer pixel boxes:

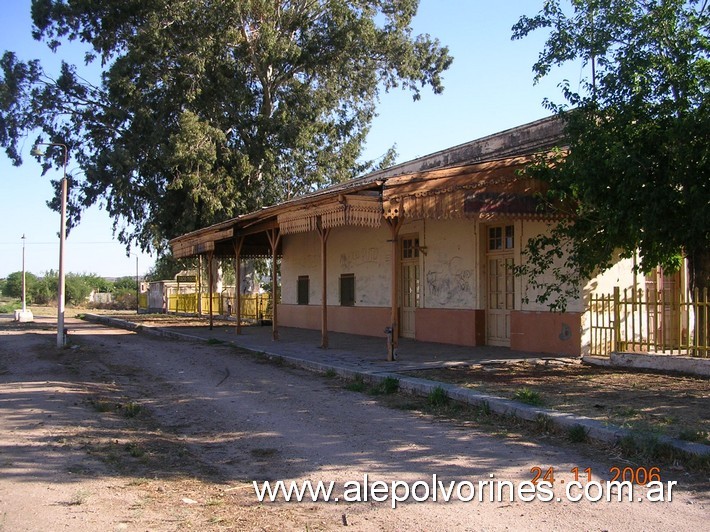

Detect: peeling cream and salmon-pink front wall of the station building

[281,214,635,354]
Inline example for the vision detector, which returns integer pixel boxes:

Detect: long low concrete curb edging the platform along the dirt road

[83,314,710,456]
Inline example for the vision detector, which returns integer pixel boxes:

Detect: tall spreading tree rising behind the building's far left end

[0,0,451,254]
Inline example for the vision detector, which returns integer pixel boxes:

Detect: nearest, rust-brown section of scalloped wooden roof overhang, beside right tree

[382,156,558,220]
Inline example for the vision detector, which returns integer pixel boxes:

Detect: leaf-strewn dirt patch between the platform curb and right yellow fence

[406,361,710,444]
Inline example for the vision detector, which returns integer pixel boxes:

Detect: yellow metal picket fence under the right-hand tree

[588,287,710,358]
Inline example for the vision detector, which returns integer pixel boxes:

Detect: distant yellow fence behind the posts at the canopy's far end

[167,293,272,321]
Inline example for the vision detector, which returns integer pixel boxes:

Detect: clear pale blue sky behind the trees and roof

[0,0,587,277]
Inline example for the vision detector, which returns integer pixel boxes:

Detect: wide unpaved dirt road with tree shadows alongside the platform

[0,318,710,531]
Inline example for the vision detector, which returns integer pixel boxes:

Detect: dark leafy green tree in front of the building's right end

[513,0,710,307]
